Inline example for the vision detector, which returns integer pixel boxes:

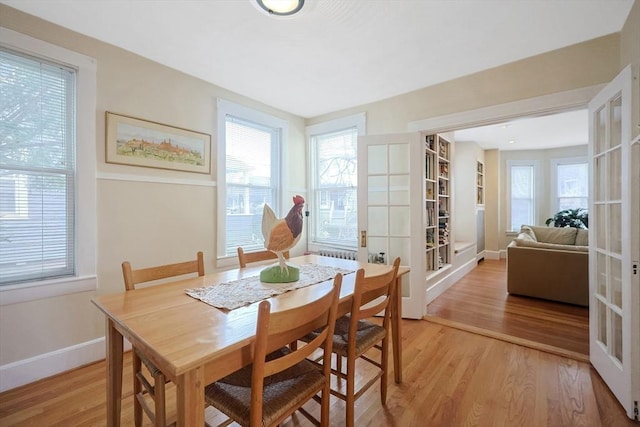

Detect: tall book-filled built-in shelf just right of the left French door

[424,135,452,271]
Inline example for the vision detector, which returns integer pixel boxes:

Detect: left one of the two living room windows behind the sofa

[507,161,536,231]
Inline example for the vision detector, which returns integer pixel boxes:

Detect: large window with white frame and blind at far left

[0,28,96,305]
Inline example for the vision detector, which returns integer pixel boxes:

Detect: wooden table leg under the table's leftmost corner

[105,319,123,427]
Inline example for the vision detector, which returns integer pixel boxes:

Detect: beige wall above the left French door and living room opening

[309,35,620,135]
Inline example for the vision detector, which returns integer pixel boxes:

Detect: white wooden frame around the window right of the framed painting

[216,98,289,267]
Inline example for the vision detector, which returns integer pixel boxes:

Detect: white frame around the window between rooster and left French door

[305,113,366,252]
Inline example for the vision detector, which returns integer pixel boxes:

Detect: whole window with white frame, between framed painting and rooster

[218,100,287,257]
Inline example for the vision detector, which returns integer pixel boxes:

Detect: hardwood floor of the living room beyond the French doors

[427,260,589,361]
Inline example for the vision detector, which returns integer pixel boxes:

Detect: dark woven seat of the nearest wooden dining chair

[205,348,325,425]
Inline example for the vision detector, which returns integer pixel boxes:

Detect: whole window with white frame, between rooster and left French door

[307,114,364,250]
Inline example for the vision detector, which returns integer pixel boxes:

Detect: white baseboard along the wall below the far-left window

[0,337,131,392]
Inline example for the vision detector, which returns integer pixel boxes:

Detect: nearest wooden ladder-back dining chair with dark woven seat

[205,274,342,427]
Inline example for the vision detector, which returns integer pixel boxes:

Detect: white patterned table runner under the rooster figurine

[185,264,354,310]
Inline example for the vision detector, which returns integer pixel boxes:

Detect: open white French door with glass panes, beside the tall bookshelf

[358,133,426,319]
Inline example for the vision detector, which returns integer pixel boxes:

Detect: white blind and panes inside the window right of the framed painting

[224,115,281,255]
